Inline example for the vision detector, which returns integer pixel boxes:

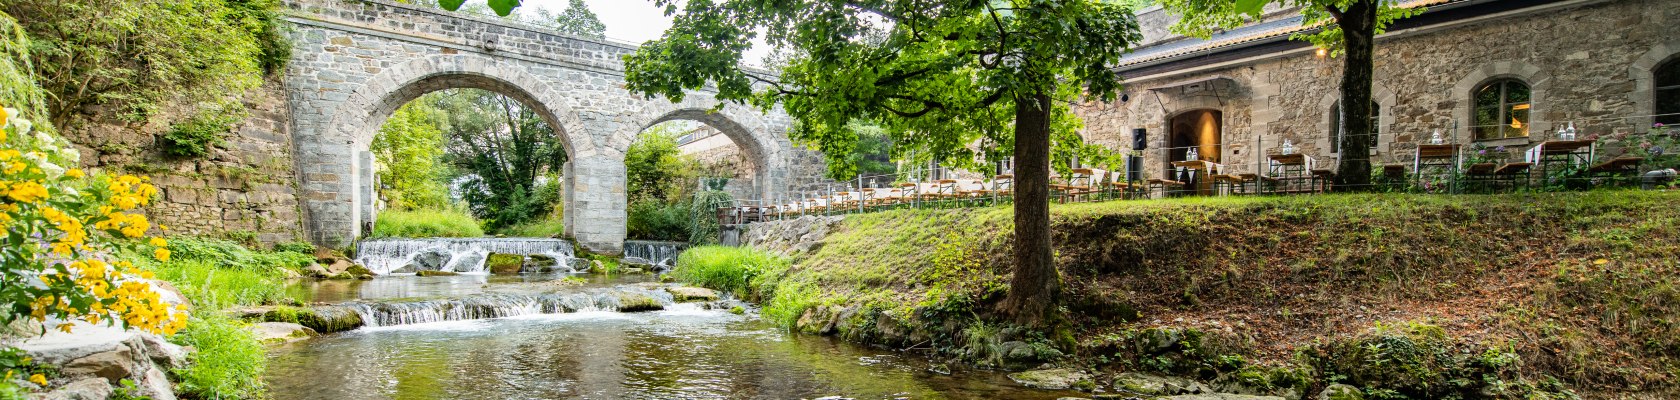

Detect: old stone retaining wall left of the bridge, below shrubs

[64,79,302,244]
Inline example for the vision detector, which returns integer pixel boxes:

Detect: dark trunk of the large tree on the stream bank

[1003,92,1062,326]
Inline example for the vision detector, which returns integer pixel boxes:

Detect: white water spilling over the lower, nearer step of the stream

[336,287,675,326]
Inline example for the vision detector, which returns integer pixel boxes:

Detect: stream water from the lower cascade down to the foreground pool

[267,276,1077,400]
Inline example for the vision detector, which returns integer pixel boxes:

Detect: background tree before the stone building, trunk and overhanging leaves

[1161,0,1423,190]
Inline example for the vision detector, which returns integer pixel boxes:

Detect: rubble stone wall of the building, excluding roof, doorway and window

[1077,0,1680,176]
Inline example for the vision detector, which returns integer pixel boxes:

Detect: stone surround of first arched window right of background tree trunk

[1440,61,1556,145]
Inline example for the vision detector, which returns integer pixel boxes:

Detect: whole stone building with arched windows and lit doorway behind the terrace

[1075,0,1680,178]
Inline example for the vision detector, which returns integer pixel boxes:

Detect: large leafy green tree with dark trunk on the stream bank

[625,0,1139,326]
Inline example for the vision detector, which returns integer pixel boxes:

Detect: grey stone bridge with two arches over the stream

[284,0,820,254]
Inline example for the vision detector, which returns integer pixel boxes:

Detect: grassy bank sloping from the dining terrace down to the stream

[766,192,1680,393]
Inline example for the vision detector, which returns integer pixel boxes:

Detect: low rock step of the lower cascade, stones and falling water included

[245,286,719,333]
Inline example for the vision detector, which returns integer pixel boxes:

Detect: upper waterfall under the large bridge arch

[356,237,573,274]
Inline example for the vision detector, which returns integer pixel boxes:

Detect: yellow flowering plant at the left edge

[0,108,186,334]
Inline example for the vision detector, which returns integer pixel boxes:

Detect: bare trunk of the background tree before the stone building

[1331,0,1379,192]
